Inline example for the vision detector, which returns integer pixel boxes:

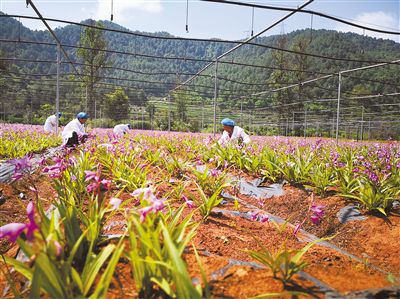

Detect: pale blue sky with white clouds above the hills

[0,0,400,43]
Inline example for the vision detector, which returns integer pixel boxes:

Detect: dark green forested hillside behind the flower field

[0,12,400,137]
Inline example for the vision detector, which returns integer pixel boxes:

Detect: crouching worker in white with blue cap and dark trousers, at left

[62,112,89,147]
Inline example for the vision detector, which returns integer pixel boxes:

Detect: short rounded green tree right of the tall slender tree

[105,87,129,120]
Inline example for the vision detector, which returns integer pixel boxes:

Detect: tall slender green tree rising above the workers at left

[77,21,109,117]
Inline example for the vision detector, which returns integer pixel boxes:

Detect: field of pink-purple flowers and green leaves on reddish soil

[0,125,400,298]
